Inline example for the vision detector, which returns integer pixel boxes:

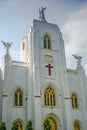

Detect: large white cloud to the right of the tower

[62,6,87,73]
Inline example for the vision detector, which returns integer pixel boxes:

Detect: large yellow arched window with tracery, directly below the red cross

[44,87,56,106]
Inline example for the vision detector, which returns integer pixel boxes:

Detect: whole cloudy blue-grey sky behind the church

[0,0,87,75]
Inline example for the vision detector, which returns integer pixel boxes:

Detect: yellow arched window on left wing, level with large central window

[14,88,23,106]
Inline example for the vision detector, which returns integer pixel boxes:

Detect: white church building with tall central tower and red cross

[0,8,87,130]
